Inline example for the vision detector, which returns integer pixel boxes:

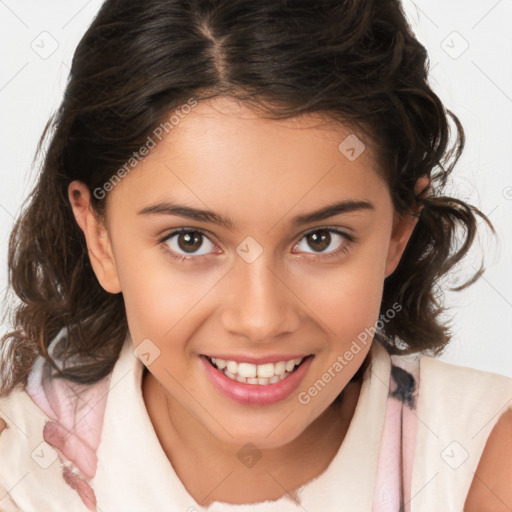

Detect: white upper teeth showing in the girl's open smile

[204,354,313,386]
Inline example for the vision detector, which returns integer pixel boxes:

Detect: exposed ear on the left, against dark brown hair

[68,180,121,293]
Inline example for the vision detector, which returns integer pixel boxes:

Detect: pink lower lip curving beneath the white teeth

[199,356,313,405]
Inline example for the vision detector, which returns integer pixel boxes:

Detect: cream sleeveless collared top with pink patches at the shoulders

[0,335,512,512]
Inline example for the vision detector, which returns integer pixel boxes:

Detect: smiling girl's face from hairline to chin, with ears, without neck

[70,97,420,448]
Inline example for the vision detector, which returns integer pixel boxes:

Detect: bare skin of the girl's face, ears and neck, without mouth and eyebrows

[69,97,428,505]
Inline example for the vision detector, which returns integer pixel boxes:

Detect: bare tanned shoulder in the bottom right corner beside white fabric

[464,407,512,512]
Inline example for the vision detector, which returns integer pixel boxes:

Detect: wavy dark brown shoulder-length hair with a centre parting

[0,0,493,394]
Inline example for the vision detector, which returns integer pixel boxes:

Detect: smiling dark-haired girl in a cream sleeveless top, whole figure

[0,0,512,512]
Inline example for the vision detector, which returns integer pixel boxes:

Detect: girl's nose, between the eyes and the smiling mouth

[221,252,301,343]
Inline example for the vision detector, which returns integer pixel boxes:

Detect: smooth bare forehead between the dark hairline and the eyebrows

[109,97,385,223]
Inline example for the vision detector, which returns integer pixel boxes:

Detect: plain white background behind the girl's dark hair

[0,0,512,377]
